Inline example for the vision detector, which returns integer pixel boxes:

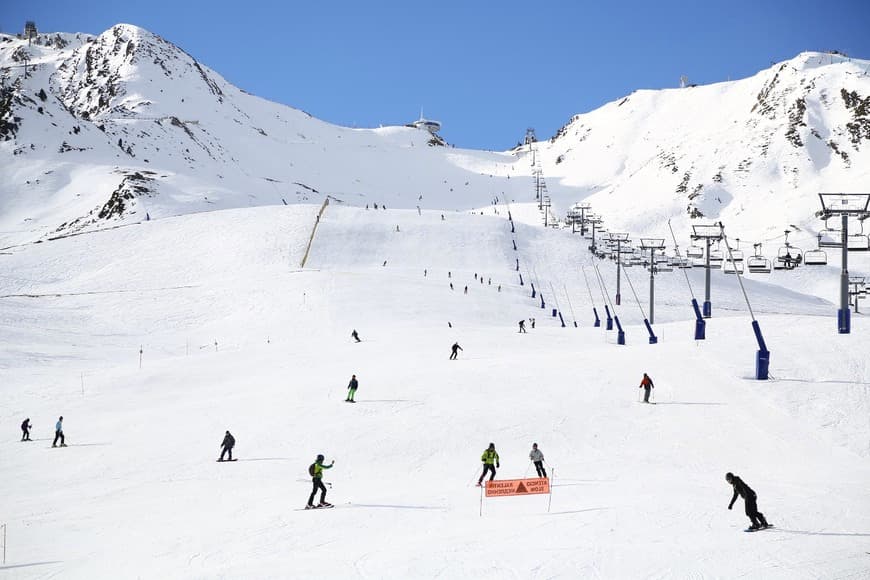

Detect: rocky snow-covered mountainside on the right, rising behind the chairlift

[538,52,870,244]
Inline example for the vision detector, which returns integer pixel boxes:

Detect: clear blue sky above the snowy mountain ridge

[0,0,870,150]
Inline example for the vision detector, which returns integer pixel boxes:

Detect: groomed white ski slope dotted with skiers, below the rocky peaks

[0,202,870,579]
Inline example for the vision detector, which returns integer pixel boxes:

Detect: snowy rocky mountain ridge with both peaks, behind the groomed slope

[0,24,870,249]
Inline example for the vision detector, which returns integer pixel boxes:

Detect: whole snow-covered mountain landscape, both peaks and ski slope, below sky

[0,20,870,580]
